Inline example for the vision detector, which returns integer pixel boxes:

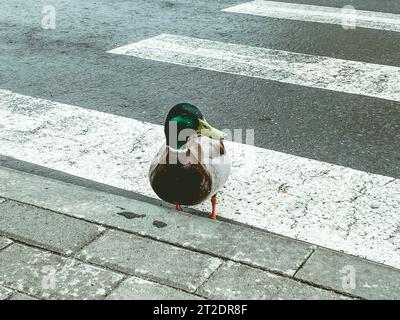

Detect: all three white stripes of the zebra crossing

[0,1,400,268]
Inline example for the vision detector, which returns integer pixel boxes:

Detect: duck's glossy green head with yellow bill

[164,103,226,149]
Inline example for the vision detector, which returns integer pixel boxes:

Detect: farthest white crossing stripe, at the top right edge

[222,0,400,32]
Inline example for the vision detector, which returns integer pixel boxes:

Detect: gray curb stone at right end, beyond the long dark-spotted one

[296,248,400,300]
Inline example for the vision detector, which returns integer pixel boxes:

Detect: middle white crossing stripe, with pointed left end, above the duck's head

[108,34,400,101]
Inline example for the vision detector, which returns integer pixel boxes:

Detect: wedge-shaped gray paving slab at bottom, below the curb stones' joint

[197,261,346,300]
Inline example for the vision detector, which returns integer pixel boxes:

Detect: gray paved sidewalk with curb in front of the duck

[0,167,400,299]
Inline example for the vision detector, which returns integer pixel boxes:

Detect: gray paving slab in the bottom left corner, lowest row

[0,244,123,299]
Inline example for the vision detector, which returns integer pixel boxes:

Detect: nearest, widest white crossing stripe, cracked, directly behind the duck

[0,90,400,268]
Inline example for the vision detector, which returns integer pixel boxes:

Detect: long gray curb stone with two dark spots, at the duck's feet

[0,169,312,275]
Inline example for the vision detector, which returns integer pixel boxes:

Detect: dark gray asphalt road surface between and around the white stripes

[0,0,400,177]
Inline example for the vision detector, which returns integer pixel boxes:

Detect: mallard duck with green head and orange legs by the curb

[149,103,231,219]
